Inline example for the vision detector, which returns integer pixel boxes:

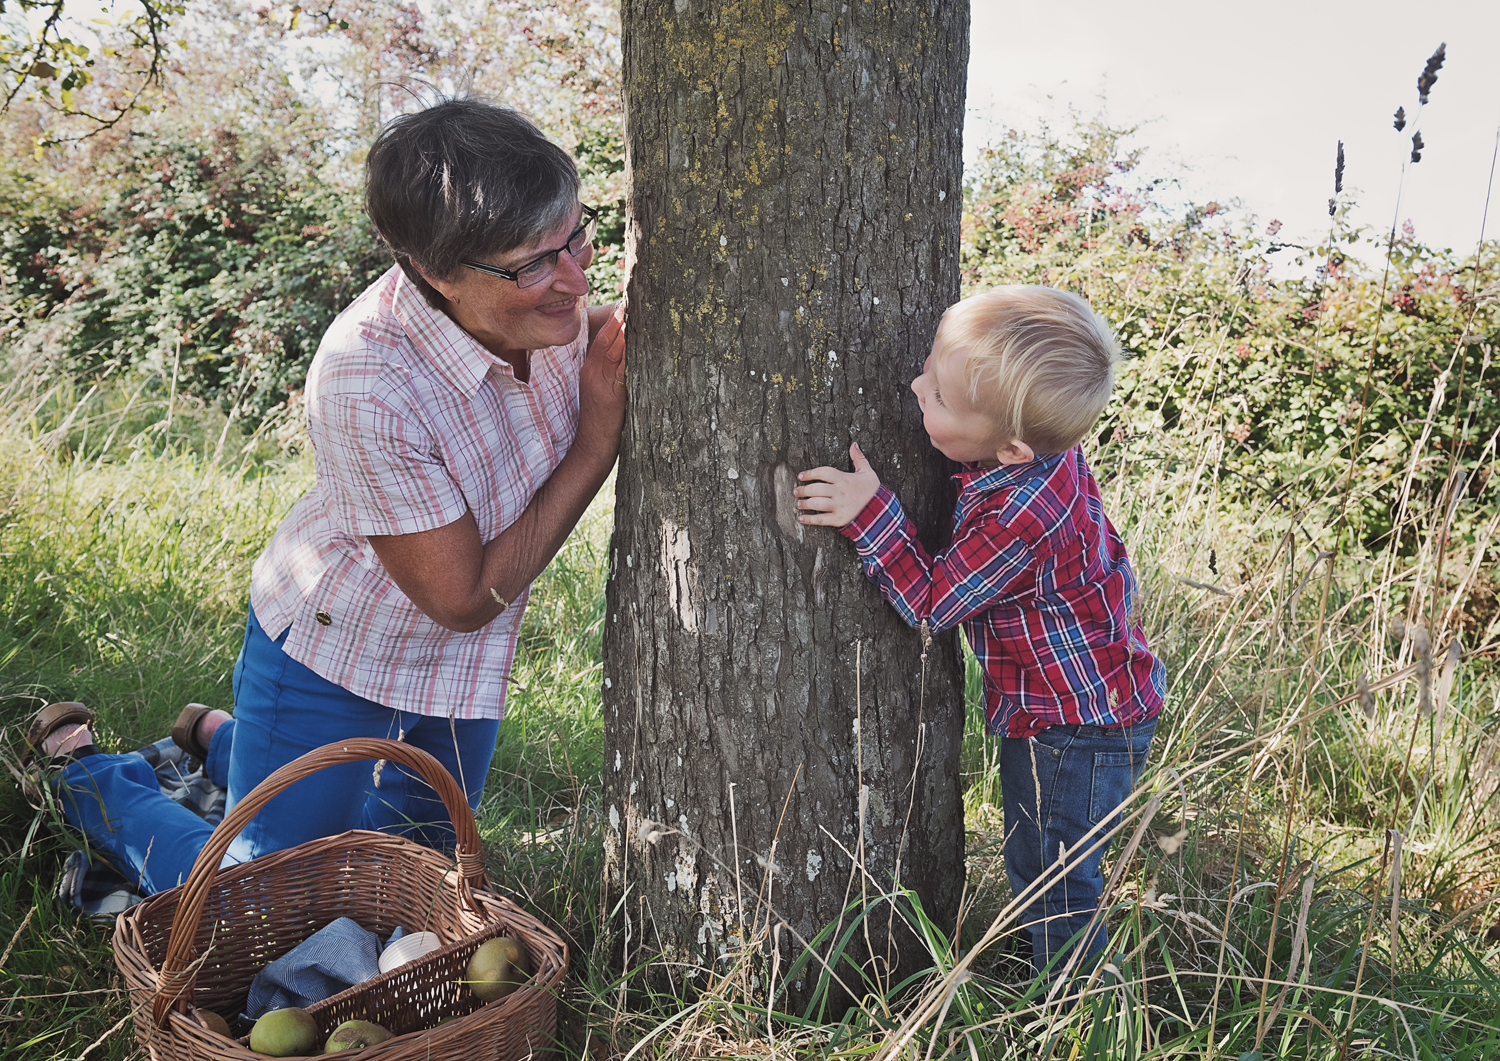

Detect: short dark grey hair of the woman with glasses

[365,96,578,308]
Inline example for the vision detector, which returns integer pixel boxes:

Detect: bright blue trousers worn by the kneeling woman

[57,609,500,893]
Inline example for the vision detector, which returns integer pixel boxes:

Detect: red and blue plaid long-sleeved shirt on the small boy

[840,449,1167,737]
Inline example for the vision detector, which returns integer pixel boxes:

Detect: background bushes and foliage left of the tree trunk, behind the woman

[0,0,624,435]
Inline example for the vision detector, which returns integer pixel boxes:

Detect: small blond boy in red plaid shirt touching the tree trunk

[795,285,1166,972]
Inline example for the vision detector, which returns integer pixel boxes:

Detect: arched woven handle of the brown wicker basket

[152,737,489,1026]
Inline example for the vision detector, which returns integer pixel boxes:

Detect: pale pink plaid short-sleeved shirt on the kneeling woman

[251,267,588,719]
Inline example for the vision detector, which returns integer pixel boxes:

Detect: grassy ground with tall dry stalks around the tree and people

[0,354,1500,1058]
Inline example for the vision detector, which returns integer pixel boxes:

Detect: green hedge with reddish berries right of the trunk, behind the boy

[965,122,1500,552]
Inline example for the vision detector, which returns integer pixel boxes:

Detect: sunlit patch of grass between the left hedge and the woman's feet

[0,390,308,747]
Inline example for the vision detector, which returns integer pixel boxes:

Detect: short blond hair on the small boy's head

[935,284,1121,453]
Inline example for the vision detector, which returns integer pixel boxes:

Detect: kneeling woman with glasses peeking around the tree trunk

[29,99,624,891]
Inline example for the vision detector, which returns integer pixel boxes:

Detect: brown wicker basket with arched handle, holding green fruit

[114,738,567,1061]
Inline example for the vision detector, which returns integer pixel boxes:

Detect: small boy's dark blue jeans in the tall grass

[1001,719,1157,975]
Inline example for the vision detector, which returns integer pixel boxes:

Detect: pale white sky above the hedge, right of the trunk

[965,0,1500,265]
